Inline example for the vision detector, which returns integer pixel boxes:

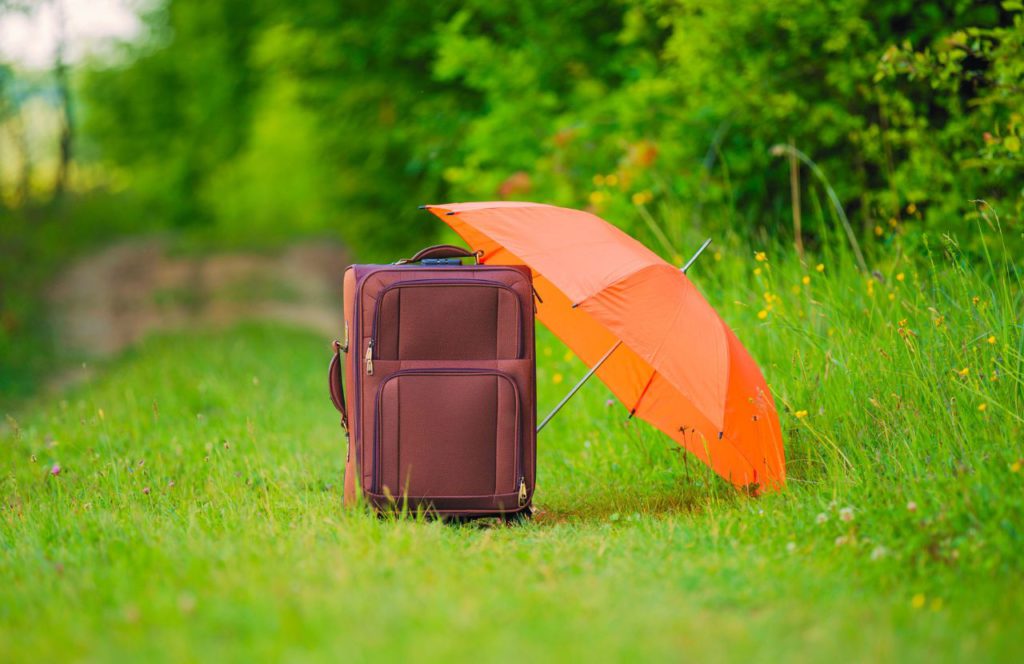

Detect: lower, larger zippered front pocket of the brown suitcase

[372,369,523,507]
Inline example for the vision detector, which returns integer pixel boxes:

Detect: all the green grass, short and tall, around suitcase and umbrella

[0,221,1024,661]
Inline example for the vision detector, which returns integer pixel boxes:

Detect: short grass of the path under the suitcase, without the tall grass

[0,328,1022,661]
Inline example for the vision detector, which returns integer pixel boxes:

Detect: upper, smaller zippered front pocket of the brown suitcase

[366,279,523,366]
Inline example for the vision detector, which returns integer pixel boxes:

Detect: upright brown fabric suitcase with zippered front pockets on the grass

[330,245,537,516]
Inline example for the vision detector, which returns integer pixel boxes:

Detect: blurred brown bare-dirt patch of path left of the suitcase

[47,239,349,381]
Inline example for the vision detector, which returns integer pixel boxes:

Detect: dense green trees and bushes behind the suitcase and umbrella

[75,0,1024,256]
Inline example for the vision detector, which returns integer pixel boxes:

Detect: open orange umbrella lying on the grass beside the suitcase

[424,202,785,492]
